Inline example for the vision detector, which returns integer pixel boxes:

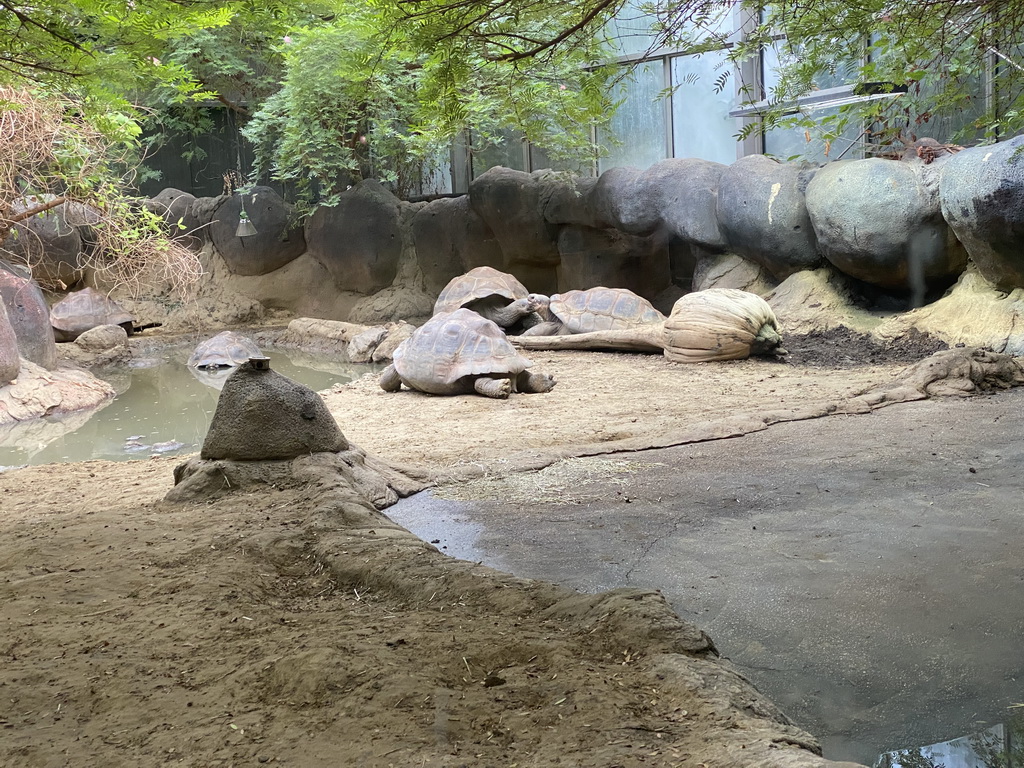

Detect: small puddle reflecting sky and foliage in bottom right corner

[874,714,1024,768]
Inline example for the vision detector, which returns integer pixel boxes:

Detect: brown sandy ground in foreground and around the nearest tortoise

[0,339,1015,768]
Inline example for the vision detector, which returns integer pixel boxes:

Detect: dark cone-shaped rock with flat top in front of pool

[200,362,348,461]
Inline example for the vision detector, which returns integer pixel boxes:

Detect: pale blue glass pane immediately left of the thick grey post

[671,51,738,165]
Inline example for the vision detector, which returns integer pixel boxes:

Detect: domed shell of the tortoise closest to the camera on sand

[394,309,532,394]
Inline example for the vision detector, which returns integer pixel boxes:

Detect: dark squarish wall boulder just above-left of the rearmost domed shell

[412,195,504,296]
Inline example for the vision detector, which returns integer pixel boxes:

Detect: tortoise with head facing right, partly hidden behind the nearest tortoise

[433,266,541,329]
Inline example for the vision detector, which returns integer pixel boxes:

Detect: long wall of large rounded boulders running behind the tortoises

[12,136,1024,346]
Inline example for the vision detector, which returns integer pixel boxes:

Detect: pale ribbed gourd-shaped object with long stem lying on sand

[511,288,785,362]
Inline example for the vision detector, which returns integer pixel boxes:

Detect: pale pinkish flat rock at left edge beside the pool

[0,357,115,423]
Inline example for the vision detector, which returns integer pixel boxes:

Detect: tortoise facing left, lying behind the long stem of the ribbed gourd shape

[522,287,665,336]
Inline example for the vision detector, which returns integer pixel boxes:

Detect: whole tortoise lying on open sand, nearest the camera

[380,309,555,398]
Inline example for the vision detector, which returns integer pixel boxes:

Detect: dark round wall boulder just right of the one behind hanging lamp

[306,179,402,295]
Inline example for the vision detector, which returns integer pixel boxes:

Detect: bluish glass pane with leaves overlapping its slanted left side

[597,59,668,172]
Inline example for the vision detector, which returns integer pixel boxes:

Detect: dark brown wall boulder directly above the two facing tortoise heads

[469,166,559,272]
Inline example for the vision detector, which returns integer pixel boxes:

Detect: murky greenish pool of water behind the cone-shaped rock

[0,347,380,470]
